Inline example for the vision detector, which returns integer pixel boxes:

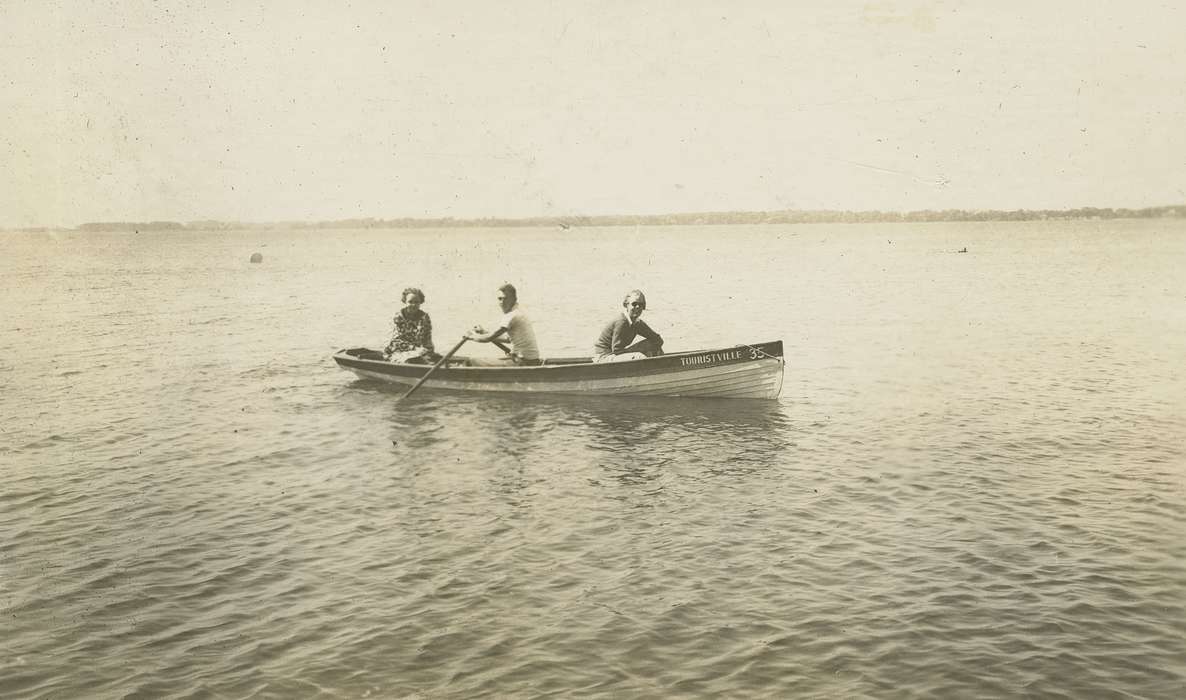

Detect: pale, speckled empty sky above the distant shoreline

[0,0,1186,227]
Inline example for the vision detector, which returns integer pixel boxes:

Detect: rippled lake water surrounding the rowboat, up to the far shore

[0,219,1186,698]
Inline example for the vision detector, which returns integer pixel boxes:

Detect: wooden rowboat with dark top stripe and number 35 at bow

[333,341,784,399]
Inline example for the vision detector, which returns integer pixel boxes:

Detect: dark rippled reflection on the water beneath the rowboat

[426,386,802,483]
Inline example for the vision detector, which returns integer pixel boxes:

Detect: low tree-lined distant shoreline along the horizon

[6,204,1186,233]
